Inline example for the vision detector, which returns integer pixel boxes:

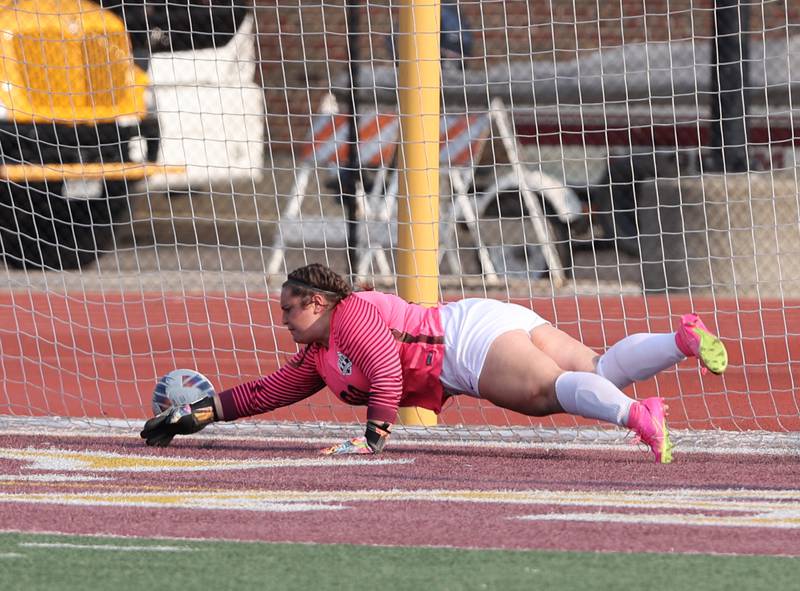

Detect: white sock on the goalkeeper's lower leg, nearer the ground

[556,371,634,427]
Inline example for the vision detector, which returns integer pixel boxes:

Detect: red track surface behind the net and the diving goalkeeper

[0,292,800,432]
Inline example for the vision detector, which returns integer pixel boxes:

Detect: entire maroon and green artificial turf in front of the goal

[0,429,800,591]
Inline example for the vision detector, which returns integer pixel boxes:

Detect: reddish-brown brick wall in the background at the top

[256,0,800,153]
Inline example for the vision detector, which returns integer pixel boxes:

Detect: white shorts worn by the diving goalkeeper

[440,298,550,398]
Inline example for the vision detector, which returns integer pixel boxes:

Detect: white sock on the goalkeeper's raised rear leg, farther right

[595,333,686,389]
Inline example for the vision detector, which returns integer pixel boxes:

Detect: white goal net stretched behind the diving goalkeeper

[0,0,800,442]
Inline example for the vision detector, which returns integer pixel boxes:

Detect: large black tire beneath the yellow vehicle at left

[0,181,130,271]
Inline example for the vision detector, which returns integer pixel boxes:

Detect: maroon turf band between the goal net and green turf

[0,434,800,556]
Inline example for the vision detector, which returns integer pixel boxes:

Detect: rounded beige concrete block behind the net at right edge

[639,170,800,297]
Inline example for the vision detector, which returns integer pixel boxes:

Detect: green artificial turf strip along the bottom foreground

[0,524,800,591]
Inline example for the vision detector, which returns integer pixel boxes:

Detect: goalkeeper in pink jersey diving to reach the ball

[141,264,727,463]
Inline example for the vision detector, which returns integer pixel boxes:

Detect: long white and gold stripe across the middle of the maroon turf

[0,489,800,529]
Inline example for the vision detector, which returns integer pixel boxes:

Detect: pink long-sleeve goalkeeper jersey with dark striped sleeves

[218,291,444,423]
